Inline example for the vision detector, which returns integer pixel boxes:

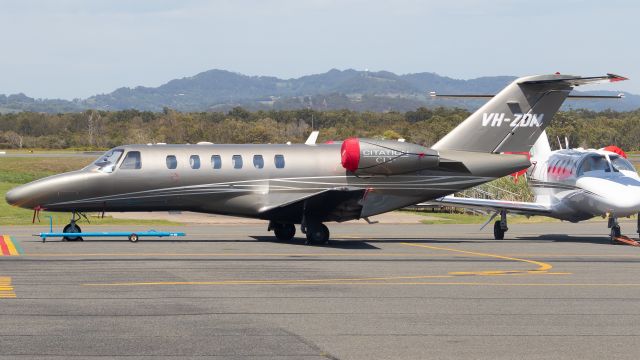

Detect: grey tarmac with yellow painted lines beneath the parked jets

[0,222,640,359]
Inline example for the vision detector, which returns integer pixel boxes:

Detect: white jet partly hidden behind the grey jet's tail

[439,132,640,242]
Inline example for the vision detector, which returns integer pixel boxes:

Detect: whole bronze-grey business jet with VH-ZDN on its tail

[6,74,624,243]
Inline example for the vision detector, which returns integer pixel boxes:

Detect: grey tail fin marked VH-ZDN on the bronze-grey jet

[433,74,626,153]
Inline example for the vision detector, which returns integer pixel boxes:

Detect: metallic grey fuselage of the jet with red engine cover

[7,142,529,223]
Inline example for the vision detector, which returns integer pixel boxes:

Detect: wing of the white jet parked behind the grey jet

[434,196,551,216]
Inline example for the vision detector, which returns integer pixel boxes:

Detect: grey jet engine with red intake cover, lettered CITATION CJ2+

[341,138,440,175]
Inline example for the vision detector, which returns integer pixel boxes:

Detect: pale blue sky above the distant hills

[0,0,640,99]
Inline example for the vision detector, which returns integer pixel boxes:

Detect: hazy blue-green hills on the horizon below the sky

[0,69,640,113]
